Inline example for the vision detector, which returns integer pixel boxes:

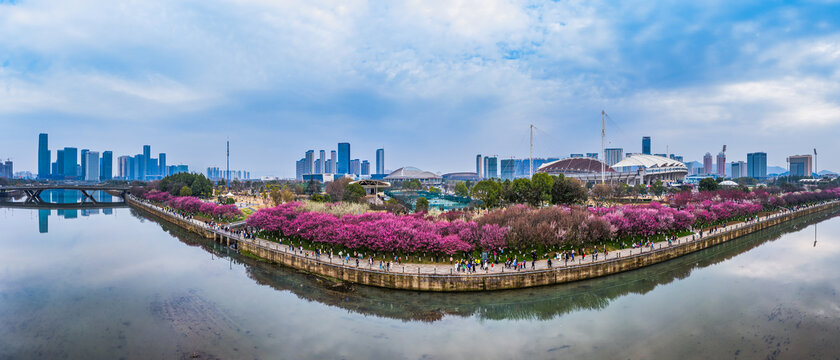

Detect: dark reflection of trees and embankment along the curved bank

[132,210,840,322]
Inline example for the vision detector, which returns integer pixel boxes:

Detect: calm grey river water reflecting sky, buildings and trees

[0,198,840,359]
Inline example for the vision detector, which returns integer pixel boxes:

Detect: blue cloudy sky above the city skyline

[0,0,840,177]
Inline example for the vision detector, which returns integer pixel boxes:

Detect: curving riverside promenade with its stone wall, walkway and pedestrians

[126,196,840,291]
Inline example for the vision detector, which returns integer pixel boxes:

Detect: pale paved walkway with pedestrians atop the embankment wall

[131,198,832,276]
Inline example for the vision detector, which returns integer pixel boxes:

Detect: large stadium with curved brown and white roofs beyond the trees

[538,155,688,185]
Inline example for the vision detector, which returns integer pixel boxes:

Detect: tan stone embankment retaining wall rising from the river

[129,197,840,291]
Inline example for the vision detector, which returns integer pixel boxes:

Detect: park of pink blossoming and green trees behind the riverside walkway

[131,173,840,267]
